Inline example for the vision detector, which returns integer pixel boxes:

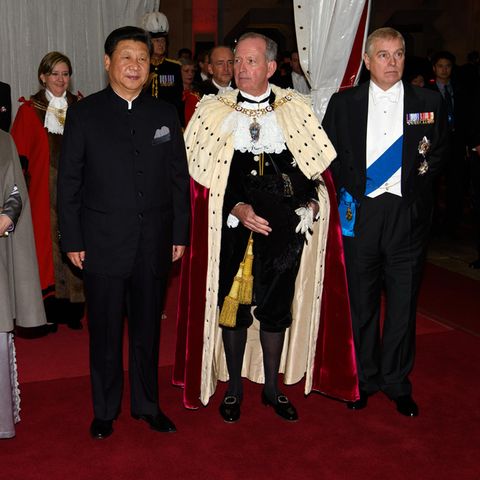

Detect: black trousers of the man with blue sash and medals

[343,193,431,398]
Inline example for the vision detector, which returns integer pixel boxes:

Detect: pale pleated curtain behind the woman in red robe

[0,0,158,120]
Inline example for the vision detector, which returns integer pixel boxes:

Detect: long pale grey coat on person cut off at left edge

[0,130,45,332]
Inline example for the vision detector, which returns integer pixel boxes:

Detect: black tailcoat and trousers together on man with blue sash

[323,82,447,398]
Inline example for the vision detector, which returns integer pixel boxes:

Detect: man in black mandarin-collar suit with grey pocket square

[58,27,189,438]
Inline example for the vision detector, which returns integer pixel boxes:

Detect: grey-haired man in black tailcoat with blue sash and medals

[323,28,447,416]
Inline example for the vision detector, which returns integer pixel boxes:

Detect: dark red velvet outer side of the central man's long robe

[173,170,359,409]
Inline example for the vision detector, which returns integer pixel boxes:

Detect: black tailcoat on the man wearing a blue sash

[323,82,447,209]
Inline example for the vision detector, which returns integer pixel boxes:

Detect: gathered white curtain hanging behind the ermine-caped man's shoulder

[293,0,368,120]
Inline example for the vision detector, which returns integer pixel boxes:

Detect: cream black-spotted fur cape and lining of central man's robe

[185,85,336,404]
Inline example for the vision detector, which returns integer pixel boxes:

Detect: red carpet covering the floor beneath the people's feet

[4,264,480,480]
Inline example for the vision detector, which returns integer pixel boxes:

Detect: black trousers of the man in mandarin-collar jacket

[84,246,171,420]
